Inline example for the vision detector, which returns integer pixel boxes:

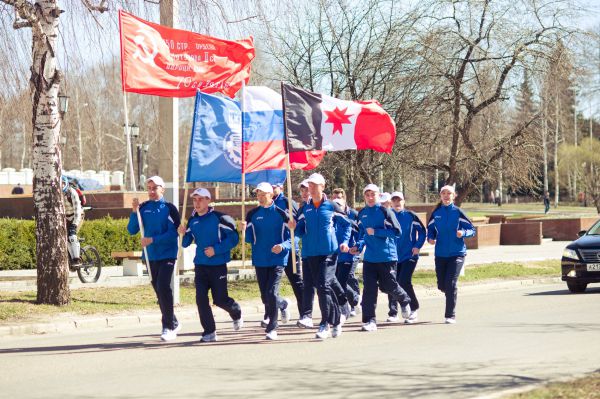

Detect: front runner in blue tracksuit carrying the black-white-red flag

[292,173,352,339]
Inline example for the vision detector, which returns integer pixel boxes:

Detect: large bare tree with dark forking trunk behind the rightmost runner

[410,0,569,203]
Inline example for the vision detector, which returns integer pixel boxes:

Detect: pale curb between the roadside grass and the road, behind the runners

[0,277,561,340]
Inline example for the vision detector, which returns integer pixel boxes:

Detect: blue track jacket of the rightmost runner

[427,204,475,258]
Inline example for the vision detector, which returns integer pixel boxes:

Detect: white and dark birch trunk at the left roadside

[30,0,70,305]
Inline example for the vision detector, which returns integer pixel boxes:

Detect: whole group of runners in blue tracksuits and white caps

[128,173,475,342]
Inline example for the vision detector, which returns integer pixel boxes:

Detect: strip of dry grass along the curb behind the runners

[0,260,560,324]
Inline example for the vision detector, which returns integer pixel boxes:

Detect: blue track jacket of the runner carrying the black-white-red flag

[295,195,352,258]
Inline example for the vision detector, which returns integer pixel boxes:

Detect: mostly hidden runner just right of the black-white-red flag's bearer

[331,188,360,316]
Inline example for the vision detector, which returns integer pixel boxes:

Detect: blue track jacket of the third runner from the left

[246,202,291,267]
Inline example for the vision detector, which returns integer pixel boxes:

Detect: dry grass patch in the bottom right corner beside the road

[505,373,600,399]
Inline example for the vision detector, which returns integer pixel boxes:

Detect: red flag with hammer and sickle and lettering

[119,11,255,97]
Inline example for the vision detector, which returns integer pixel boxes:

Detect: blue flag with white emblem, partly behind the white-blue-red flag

[186,92,285,185]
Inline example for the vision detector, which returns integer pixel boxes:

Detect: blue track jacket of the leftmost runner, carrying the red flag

[127,198,181,261]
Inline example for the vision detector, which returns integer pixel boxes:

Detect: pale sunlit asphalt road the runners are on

[0,284,600,399]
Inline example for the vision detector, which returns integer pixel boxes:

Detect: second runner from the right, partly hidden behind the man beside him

[387,191,426,323]
